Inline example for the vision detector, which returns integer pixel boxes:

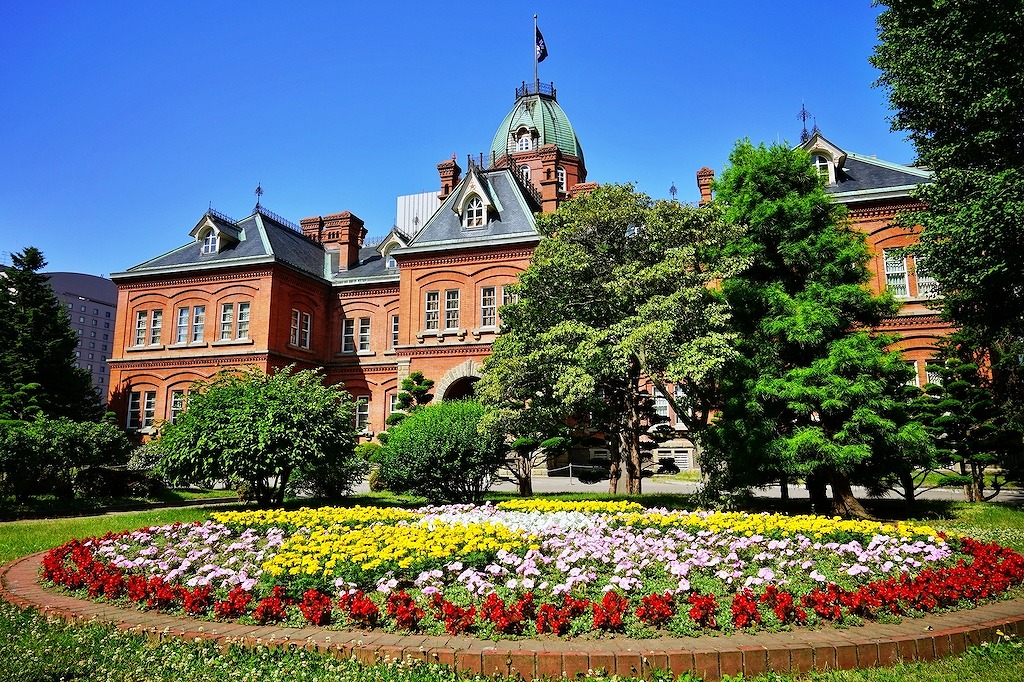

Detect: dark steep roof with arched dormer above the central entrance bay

[396,168,539,254]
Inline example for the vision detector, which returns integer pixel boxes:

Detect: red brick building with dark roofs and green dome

[110,85,946,456]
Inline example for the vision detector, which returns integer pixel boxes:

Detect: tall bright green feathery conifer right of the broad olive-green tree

[706,141,929,515]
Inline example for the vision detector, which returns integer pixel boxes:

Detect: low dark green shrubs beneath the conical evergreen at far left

[0,417,131,502]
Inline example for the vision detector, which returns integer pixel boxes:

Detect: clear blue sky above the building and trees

[0,0,913,274]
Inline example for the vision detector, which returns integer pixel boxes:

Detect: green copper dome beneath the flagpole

[490,85,583,164]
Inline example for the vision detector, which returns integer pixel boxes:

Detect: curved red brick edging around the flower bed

[0,552,1024,681]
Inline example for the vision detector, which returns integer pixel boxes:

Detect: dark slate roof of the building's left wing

[111,209,325,280]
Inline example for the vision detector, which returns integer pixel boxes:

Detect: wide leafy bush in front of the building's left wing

[159,367,366,504]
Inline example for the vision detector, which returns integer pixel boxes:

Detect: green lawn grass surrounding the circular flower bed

[0,494,1024,682]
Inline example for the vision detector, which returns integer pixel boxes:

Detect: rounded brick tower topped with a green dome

[490,82,587,213]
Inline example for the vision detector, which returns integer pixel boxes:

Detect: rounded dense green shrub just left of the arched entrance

[377,401,506,502]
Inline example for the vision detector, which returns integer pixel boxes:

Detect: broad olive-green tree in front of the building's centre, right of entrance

[475,185,741,494]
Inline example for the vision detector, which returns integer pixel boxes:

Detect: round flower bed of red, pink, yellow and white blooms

[43,500,1024,637]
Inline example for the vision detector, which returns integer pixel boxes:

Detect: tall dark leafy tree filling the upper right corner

[871,0,1024,426]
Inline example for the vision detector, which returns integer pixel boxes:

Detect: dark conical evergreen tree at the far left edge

[0,247,102,420]
